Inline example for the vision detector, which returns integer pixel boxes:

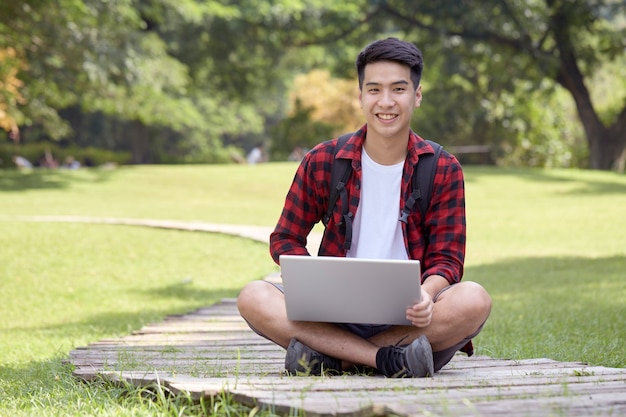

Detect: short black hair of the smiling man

[356,38,424,89]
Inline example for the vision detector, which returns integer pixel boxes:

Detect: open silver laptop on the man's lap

[280,255,421,325]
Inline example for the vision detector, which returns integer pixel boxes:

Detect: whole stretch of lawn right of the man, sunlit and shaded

[465,168,626,367]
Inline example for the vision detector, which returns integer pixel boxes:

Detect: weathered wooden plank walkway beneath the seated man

[70,300,626,417]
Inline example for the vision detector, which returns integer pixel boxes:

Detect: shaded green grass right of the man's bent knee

[471,256,626,367]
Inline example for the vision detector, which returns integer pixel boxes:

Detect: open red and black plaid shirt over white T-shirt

[270,125,466,284]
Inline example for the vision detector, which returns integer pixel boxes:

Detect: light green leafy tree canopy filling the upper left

[0,0,376,162]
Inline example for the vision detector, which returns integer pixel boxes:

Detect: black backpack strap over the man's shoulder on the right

[400,140,443,223]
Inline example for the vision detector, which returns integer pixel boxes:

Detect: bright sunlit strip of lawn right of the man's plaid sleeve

[466,168,626,265]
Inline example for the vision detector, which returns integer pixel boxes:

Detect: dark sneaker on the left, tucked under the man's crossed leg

[285,339,341,375]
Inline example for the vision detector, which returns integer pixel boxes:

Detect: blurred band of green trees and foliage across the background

[0,0,626,169]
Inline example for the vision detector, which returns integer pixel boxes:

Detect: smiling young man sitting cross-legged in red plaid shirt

[237,38,491,377]
